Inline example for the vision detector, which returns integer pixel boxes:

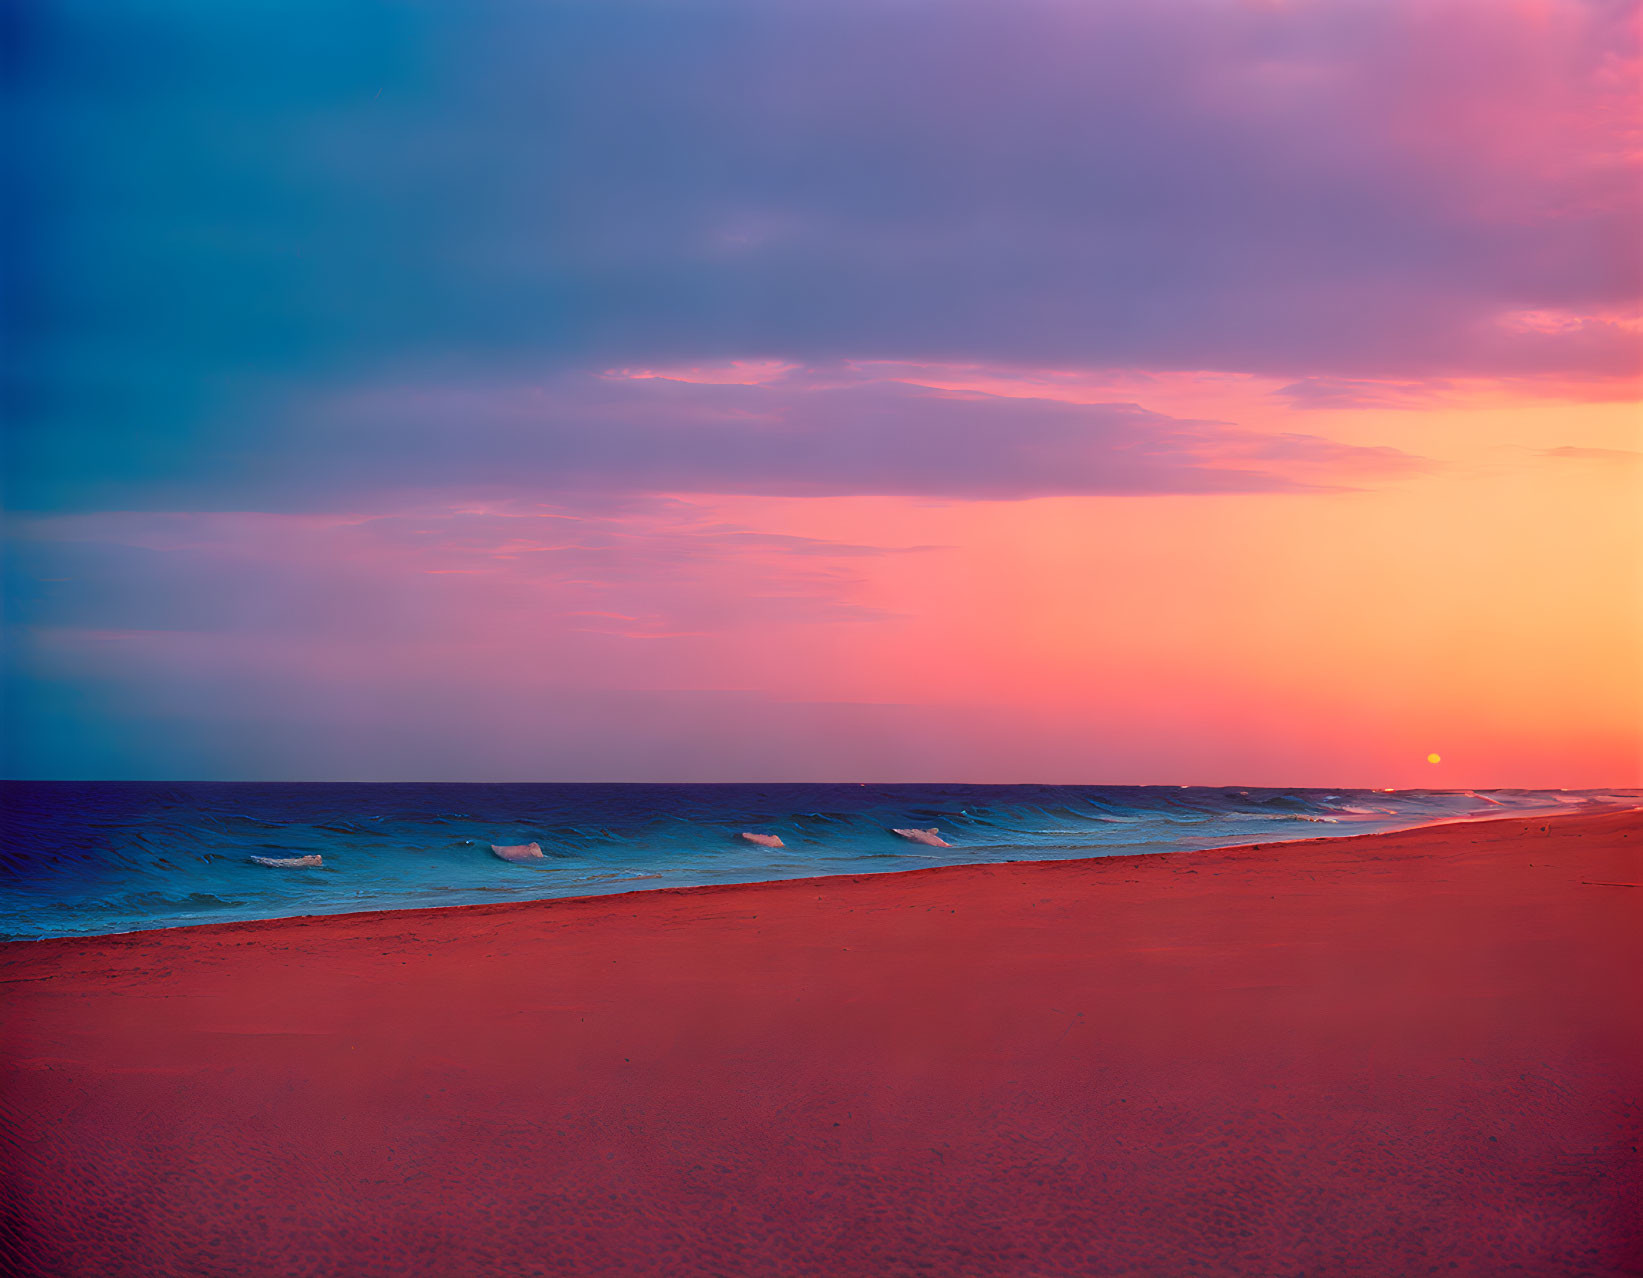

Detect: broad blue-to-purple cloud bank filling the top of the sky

[7,0,1643,509]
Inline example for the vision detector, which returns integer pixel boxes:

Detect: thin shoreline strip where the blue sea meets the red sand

[0,795,1643,953]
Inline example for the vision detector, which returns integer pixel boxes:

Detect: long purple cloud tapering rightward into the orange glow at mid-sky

[211,371,1421,506]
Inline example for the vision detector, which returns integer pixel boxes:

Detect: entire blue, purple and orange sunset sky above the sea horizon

[0,0,1643,788]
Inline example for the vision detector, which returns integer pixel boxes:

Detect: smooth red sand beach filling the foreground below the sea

[0,813,1643,1278]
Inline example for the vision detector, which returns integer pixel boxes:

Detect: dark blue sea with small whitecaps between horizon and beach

[0,782,1643,940]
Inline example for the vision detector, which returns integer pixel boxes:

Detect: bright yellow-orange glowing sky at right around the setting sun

[673,382,1643,787]
